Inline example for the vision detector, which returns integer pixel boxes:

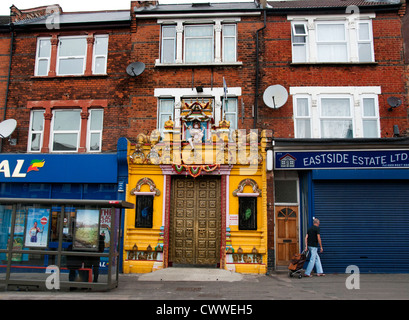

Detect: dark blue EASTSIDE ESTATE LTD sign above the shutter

[274,150,409,170]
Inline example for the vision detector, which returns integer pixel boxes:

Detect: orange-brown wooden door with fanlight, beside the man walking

[275,206,298,266]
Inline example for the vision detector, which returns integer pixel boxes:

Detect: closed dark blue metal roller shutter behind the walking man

[313,180,409,273]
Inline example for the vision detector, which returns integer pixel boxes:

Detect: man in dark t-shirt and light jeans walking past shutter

[304,219,325,277]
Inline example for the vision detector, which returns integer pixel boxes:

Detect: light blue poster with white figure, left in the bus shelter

[24,208,50,248]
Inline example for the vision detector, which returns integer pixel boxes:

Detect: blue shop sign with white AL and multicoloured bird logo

[0,154,118,183]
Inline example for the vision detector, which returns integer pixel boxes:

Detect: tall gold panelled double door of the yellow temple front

[169,177,221,266]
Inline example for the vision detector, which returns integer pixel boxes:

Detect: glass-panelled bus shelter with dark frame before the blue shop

[0,198,134,291]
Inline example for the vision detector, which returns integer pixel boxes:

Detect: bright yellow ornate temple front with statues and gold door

[123,102,267,273]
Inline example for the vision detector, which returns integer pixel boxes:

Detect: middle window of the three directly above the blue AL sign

[52,110,81,152]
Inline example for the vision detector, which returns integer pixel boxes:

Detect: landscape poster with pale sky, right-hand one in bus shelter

[73,209,99,251]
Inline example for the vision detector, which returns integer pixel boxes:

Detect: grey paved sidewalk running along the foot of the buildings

[0,268,409,303]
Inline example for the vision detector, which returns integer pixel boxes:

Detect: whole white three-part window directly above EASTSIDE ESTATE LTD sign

[290,87,381,139]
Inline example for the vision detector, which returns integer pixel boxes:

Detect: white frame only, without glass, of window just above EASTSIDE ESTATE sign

[290,86,381,139]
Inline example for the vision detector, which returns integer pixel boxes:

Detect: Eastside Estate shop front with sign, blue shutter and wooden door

[274,138,409,273]
